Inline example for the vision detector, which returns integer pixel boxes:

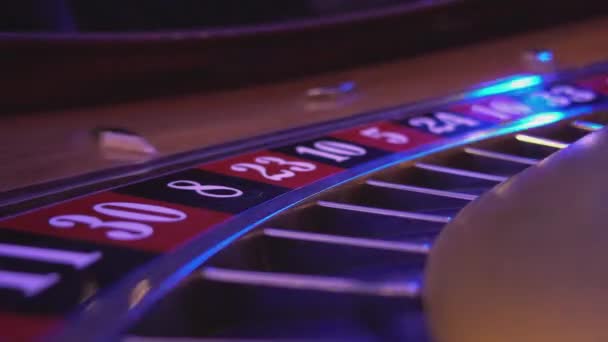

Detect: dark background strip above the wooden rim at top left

[0,0,418,32]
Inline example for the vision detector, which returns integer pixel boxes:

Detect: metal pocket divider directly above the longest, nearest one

[263,228,431,254]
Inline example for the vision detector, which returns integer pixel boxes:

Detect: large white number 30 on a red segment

[49,202,187,241]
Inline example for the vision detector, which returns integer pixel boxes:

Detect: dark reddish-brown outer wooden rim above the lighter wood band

[0,0,608,113]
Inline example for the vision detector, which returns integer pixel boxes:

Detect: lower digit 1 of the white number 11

[0,270,61,297]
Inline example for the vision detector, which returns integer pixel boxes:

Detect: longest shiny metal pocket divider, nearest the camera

[199,267,420,298]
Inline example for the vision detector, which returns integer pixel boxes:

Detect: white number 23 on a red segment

[230,156,317,182]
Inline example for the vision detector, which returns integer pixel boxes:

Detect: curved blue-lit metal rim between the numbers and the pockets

[51,106,608,340]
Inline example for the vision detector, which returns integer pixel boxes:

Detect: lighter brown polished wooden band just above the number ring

[0,18,608,191]
